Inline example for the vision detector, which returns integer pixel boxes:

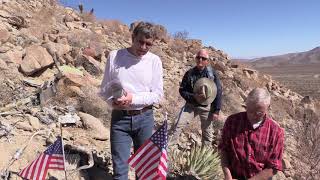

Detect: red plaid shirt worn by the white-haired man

[219,112,284,178]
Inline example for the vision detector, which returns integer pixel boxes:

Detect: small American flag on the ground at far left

[19,137,64,180]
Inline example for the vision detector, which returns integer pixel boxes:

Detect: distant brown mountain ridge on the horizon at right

[249,46,320,68]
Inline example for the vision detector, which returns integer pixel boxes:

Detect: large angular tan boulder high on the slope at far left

[20,45,54,75]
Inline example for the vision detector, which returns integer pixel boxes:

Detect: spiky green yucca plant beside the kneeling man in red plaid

[169,145,222,180]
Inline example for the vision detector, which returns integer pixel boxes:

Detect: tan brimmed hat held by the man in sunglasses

[193,77,217,105]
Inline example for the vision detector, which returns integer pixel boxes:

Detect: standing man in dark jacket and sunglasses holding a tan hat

[174,49,222,145]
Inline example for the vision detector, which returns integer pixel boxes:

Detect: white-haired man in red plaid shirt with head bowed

[219,88,284,180]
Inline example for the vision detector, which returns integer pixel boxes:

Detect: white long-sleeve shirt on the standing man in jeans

[100,49,163,110]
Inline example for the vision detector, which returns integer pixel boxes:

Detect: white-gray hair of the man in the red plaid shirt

[246,88,271,106]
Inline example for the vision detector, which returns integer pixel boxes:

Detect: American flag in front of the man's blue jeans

[128,121,168,179]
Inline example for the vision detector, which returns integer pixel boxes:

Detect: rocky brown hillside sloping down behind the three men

[0,0,320,180]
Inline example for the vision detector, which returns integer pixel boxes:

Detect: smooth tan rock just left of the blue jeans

[79,112,109,140]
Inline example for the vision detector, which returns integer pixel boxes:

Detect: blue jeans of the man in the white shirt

[110,109,154,180]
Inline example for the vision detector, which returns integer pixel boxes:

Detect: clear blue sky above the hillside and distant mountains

[61,0,320,58]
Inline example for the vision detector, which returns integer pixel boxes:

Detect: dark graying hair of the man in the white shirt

[132,21,156,39]
